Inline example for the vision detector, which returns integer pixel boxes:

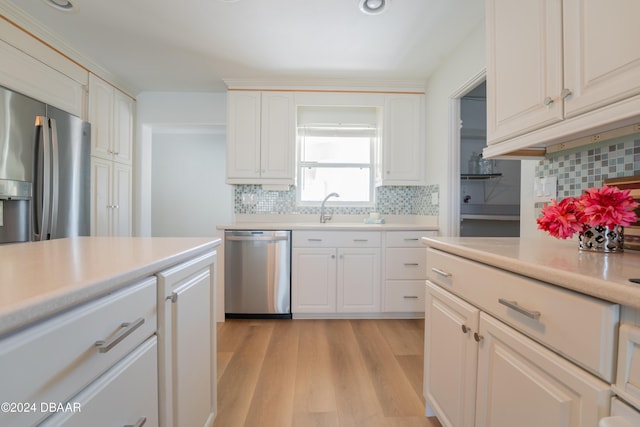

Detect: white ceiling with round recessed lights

[8,0,484,91]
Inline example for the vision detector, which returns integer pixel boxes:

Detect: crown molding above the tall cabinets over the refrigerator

[0,2,139,97]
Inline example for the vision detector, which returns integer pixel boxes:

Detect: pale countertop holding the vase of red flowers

[422,237,640,308]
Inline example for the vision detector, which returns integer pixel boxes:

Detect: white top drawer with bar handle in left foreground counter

[0,278,157,426]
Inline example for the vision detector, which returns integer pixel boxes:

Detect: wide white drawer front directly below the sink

[293,231,381,248]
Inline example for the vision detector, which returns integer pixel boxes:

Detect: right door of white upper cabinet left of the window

[260,92,296,180]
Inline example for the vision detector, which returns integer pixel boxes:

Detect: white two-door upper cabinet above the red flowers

[485,0,640,156]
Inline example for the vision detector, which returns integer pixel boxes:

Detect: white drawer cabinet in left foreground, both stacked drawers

[0,277,158,427]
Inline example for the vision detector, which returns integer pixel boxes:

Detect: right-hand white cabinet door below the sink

[337,248,381,313]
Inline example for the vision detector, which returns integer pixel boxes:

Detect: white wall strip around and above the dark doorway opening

[426,21,486,235]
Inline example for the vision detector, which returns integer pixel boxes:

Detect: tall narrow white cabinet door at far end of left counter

[158,252,217,427]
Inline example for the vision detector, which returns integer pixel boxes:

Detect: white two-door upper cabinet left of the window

[227,91,295,184]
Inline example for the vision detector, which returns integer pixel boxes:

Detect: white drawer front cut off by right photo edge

[614,324,640,408]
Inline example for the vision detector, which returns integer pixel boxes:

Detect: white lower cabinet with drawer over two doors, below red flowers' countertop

[424,248,619,427]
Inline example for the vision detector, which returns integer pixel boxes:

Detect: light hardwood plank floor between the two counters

[215,319,440,427]
